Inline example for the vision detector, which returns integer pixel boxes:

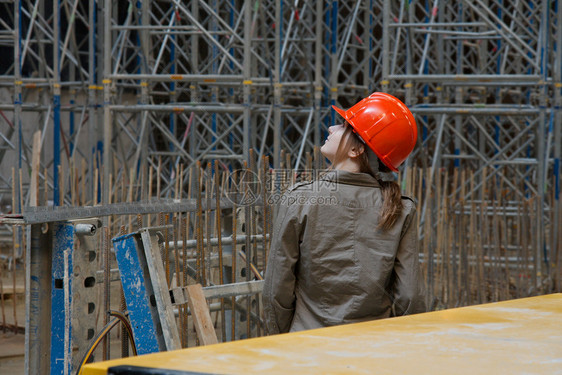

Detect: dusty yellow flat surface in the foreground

[83,294,562,375]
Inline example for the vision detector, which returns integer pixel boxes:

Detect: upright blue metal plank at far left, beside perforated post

[51,222,74,374]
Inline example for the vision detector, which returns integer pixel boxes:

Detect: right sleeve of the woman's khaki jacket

[391,202,427,316]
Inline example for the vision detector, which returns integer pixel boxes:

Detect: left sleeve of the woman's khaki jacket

[262,197,299,335]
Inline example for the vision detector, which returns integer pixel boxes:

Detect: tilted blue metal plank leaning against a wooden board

[113,234,159,354]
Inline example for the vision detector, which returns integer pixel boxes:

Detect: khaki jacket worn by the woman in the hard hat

[263,171,426,334]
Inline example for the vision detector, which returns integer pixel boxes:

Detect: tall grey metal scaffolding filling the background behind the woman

[0,0,562,334]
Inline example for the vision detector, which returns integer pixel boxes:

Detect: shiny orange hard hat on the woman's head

[332,92,418,172]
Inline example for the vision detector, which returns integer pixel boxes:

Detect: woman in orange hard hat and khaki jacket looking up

[263,93,425,334]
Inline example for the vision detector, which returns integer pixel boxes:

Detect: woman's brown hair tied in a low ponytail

[333,125,402,230]
